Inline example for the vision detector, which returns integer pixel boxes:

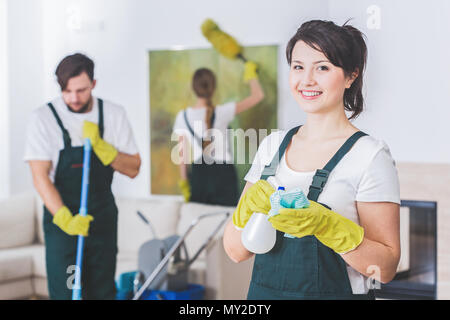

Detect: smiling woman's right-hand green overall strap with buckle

[308,131,367,201]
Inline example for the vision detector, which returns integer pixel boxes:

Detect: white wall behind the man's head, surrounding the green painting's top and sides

[36,0,327,197]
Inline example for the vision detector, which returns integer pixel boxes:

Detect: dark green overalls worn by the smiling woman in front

[247,126,374,300]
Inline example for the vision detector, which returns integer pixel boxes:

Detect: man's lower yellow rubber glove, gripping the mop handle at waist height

[53,206,94,237]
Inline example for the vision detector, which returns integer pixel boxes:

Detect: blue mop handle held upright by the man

[72,139,91,300]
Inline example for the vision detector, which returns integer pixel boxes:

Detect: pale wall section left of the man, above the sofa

[6,0,45,194]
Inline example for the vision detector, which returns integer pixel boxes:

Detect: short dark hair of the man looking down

[55,53,94,90]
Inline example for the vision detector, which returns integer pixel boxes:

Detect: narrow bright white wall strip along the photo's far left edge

[0,0,9,199]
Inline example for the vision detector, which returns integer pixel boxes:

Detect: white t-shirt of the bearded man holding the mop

[24,97,138,181]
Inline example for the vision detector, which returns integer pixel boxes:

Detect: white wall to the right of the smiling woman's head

[329,0,450,163]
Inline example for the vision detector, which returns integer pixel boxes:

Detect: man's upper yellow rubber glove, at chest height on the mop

[83,121,119,166]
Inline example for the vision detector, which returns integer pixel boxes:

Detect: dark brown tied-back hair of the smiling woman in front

[286,20,367,119]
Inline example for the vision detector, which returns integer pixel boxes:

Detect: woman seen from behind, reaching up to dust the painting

[173,61,264,206]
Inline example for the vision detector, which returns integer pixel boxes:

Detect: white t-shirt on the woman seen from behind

[173,102,236,163]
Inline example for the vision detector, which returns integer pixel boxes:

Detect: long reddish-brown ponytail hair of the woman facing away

[192,68,216,148]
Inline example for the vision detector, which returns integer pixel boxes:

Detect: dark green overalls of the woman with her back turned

[184,111,239,206]
